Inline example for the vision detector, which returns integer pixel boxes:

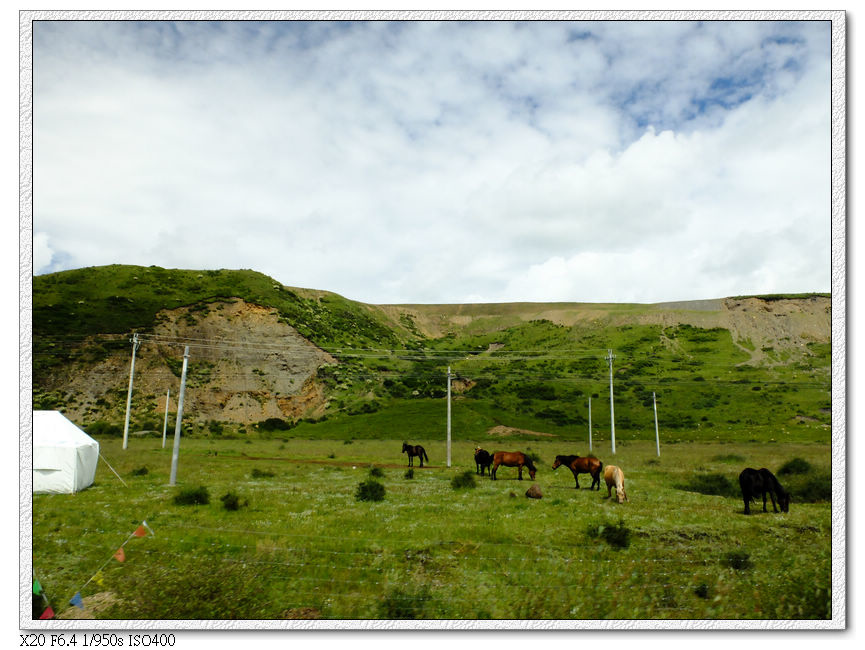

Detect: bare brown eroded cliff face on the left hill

[48,300,336,424]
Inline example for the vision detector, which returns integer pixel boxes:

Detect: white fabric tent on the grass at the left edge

[33,411,99,494]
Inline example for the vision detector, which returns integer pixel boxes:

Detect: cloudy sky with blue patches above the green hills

[33,21,832,304]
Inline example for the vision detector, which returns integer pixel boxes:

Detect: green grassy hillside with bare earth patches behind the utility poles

[33,265,831,442]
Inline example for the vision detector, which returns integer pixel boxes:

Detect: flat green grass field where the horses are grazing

[33,432,831,620]
